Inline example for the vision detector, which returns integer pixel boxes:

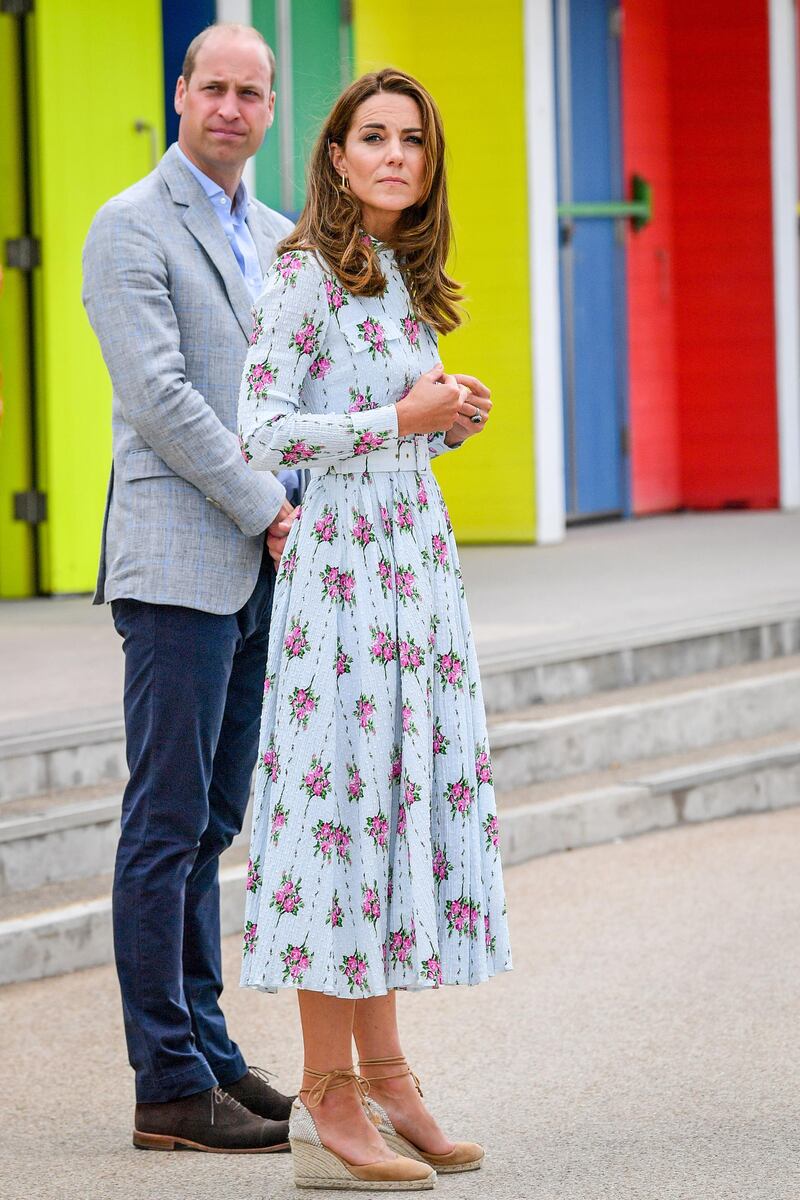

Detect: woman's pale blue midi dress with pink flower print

[239,244,511,997]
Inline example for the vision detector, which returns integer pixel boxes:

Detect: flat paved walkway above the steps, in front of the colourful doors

[0,512,800,731]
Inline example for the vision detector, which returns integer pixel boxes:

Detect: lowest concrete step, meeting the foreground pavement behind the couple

[0,738,800,984]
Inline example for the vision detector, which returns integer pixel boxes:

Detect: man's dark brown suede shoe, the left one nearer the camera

[133,1087,289,1154]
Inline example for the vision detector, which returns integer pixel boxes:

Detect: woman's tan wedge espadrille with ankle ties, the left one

[289,1068,437,1192]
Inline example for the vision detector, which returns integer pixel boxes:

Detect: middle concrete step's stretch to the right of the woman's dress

[489,656,800,792]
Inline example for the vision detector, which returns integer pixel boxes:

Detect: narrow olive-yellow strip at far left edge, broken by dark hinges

[0,16,34,599]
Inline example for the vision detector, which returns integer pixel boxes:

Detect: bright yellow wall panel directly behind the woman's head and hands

[354,0,535,541]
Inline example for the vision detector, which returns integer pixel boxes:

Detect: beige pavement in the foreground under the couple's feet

[0,809,800,1200]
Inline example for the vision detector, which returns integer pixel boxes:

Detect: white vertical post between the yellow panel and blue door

[524,0,566,545]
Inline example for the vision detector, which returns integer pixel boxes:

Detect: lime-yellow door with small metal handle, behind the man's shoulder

[32,0,163,593]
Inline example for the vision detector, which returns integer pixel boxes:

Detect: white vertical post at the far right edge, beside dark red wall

[769,0,800,509]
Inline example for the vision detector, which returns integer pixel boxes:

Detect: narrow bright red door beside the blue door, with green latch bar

[621,0,681,512]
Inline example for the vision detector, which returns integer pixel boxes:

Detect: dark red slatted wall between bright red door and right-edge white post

[667,0,778,508]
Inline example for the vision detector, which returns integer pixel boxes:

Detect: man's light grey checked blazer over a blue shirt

[83,146,291,613]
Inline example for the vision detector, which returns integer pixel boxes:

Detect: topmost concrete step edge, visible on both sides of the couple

[0,604,800,805]
